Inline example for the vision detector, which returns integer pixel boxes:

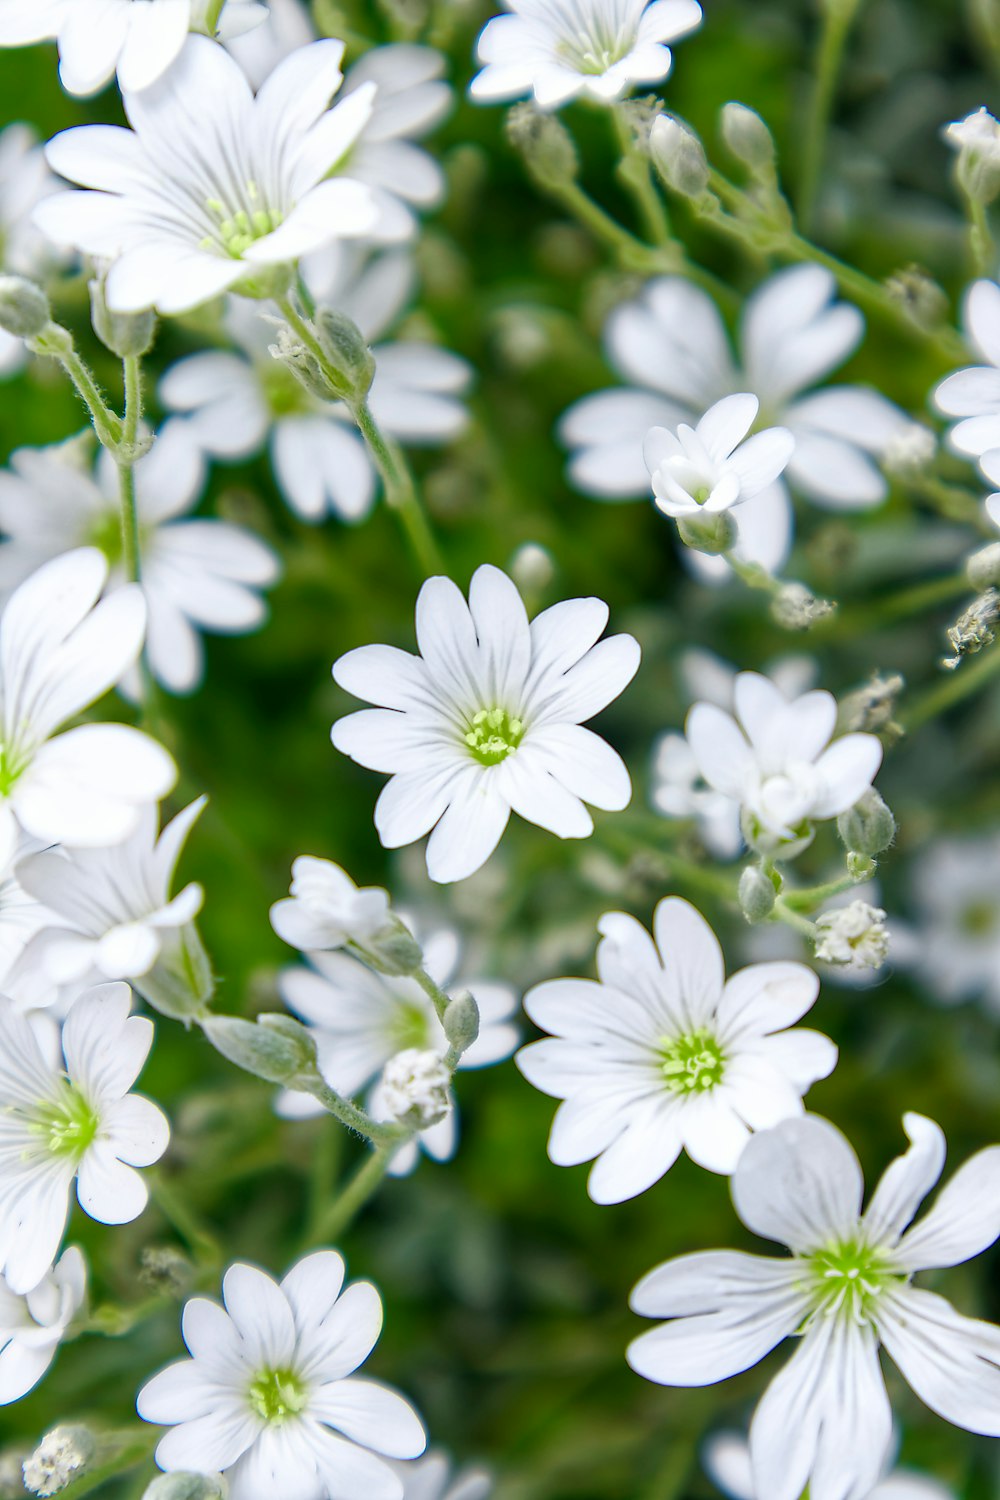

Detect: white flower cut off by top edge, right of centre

[469,0,702,110]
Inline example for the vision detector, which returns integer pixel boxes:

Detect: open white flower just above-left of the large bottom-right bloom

[517,896,837,1203]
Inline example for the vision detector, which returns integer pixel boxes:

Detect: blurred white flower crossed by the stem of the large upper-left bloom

[159,259,471,534]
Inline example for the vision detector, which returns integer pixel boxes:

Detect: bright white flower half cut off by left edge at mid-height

[0,548,177,864]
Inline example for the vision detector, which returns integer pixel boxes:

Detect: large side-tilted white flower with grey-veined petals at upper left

[34,40,386,314]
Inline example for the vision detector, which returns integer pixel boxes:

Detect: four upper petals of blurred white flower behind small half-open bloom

[561,266,910,518]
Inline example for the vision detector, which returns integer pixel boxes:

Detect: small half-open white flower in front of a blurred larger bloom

[643,395,795,519]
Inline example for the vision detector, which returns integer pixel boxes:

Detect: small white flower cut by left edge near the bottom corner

[0,1245,87,1406]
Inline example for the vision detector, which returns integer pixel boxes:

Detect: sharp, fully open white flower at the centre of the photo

[333,566,639,882]
